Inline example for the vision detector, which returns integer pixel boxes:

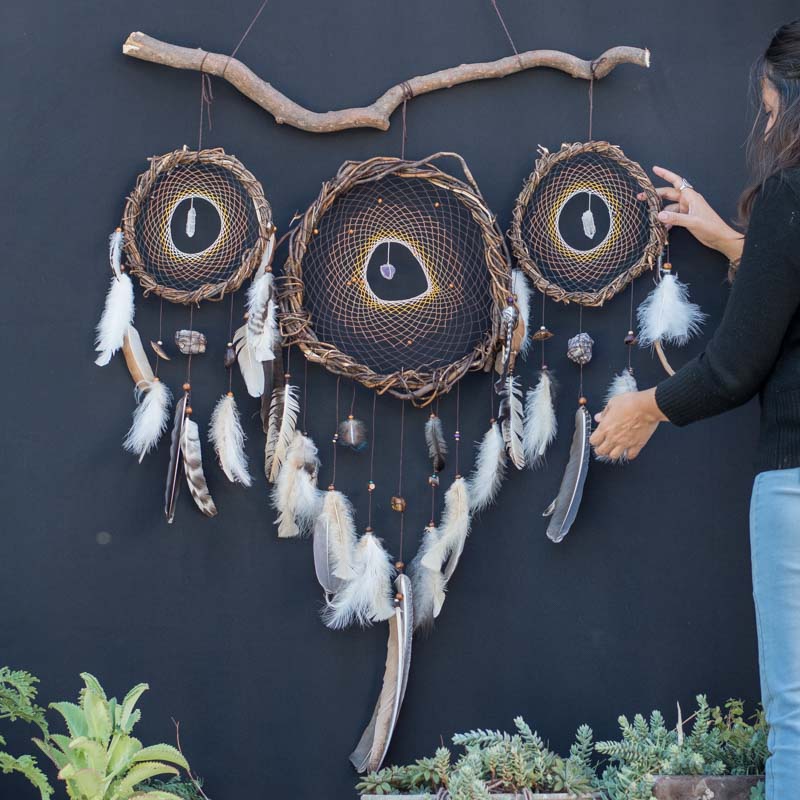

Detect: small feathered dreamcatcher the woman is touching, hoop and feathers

[509,141,701,542]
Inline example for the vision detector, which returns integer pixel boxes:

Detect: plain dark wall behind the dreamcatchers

[0,0,796,798]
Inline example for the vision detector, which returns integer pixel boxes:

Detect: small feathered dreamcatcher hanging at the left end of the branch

[96,148,279,522]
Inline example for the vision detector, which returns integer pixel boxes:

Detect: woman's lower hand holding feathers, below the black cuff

[589,389,667,460]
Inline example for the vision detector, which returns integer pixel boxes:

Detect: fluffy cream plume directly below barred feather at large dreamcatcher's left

[272,431,320,539]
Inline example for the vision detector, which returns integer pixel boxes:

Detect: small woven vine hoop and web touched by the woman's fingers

[509,142,666,306]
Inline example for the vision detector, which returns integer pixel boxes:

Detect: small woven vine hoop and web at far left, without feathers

[122,149,274,304]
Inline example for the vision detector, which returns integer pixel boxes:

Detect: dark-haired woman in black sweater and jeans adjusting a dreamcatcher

[591,20,800,800]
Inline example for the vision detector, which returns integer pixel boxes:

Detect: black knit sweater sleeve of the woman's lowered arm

[656,177,800,426]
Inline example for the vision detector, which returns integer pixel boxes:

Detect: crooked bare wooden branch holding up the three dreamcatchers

[122,31,650,133]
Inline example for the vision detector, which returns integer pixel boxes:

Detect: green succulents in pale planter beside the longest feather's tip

[356,717,595,800]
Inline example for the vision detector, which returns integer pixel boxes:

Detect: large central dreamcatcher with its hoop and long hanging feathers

[266,153,518,771]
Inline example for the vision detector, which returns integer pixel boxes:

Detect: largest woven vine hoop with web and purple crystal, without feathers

[281,153,510,406]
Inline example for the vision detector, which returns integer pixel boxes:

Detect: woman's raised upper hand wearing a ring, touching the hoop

[639,167,744,262]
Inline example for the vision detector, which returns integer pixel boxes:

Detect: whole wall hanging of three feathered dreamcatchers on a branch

[96,21,702,771]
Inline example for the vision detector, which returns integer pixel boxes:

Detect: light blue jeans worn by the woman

[750,468,800,800]
